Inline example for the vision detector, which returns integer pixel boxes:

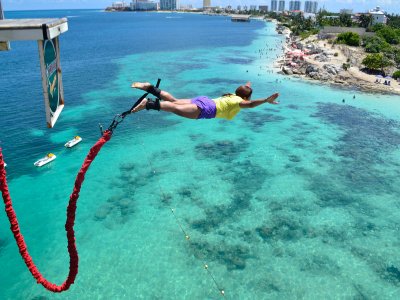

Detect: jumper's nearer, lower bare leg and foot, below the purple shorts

[132,98,201,119]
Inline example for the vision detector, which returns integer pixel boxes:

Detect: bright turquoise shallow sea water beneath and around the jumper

[0,12,400,299]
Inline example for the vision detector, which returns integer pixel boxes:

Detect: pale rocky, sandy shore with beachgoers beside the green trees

[274,28,400,95]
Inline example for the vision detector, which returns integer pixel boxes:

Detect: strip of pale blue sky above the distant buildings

[1,0,400,14]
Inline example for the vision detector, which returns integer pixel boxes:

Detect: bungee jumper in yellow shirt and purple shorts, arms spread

[132,82,279,120]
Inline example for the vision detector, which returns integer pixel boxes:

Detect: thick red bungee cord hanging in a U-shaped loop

[0,130,112,293]
